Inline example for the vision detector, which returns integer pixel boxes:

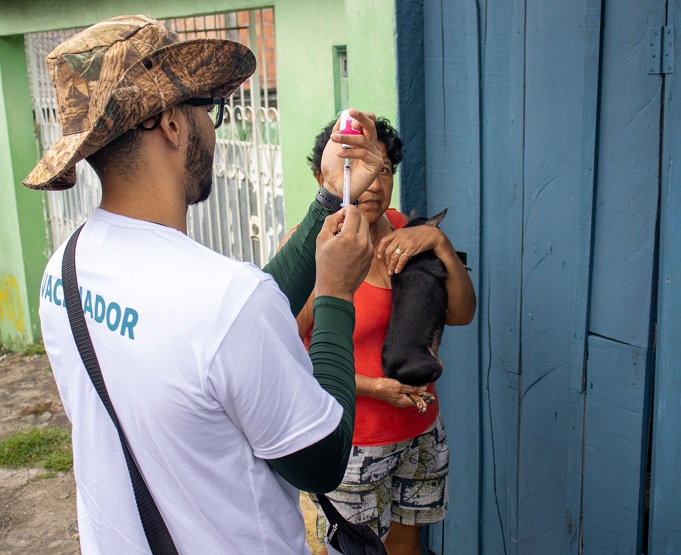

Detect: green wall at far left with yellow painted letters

[0,36,47,344]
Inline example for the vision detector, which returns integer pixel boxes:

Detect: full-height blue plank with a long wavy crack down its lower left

[476,1,525,555]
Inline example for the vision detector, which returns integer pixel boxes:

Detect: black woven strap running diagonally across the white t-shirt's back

[61,226,177,555]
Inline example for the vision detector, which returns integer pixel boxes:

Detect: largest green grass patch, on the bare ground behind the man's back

[0,428,73,472]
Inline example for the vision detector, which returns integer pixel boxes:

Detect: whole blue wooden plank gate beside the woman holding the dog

[398,0,681,555]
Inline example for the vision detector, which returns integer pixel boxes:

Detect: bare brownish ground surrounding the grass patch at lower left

[0,354,319,555]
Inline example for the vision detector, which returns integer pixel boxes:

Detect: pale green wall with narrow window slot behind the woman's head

[275,0,399,227]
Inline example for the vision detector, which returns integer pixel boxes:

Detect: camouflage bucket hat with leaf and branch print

[23,15,256,191]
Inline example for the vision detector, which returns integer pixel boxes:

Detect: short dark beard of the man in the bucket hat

[182,108,215,205]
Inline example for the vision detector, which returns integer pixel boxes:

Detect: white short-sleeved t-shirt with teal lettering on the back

[40,209,342,555]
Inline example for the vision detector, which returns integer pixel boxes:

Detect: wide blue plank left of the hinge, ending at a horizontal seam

[589,0,665,348]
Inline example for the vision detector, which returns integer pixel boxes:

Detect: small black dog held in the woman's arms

[382,209,447,414]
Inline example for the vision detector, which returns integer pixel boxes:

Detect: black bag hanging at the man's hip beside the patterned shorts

[316,493,388,555]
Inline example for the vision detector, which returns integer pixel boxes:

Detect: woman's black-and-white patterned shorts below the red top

[310,415,449,543]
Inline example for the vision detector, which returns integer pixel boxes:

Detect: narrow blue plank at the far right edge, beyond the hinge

[648,0,681,555]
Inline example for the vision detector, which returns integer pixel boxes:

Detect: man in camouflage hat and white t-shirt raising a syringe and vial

[34,16,383,555]
